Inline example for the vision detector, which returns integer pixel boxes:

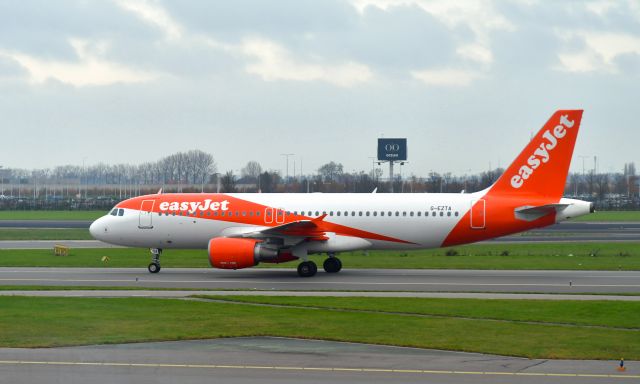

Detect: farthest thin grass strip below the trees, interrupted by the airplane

[0,210,640,222]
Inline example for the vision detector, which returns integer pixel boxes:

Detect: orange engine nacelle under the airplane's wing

[208,237,278,269]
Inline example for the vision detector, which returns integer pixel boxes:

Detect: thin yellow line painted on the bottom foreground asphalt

[0,360,640,379]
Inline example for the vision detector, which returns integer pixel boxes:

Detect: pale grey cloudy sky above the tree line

[0,0,640,175]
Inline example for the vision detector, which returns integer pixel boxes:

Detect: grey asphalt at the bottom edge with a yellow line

[0,337,640,384]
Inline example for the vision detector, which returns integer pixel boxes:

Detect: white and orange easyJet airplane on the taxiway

[89,110,594,277]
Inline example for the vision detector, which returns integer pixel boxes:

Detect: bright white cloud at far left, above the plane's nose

[0,39,156,87]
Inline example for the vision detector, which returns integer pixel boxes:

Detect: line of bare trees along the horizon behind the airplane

[0,150,638,208]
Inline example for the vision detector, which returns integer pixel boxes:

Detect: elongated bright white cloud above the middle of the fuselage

[241,38,373,87]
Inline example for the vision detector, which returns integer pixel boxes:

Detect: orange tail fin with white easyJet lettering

[490,109,582,199]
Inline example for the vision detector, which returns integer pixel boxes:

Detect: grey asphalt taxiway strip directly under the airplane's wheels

[0,267,640,293]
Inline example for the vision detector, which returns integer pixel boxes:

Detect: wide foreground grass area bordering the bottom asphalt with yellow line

[0,297,640,360]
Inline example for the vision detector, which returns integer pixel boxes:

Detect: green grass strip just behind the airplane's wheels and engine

[0,242,640,270]
